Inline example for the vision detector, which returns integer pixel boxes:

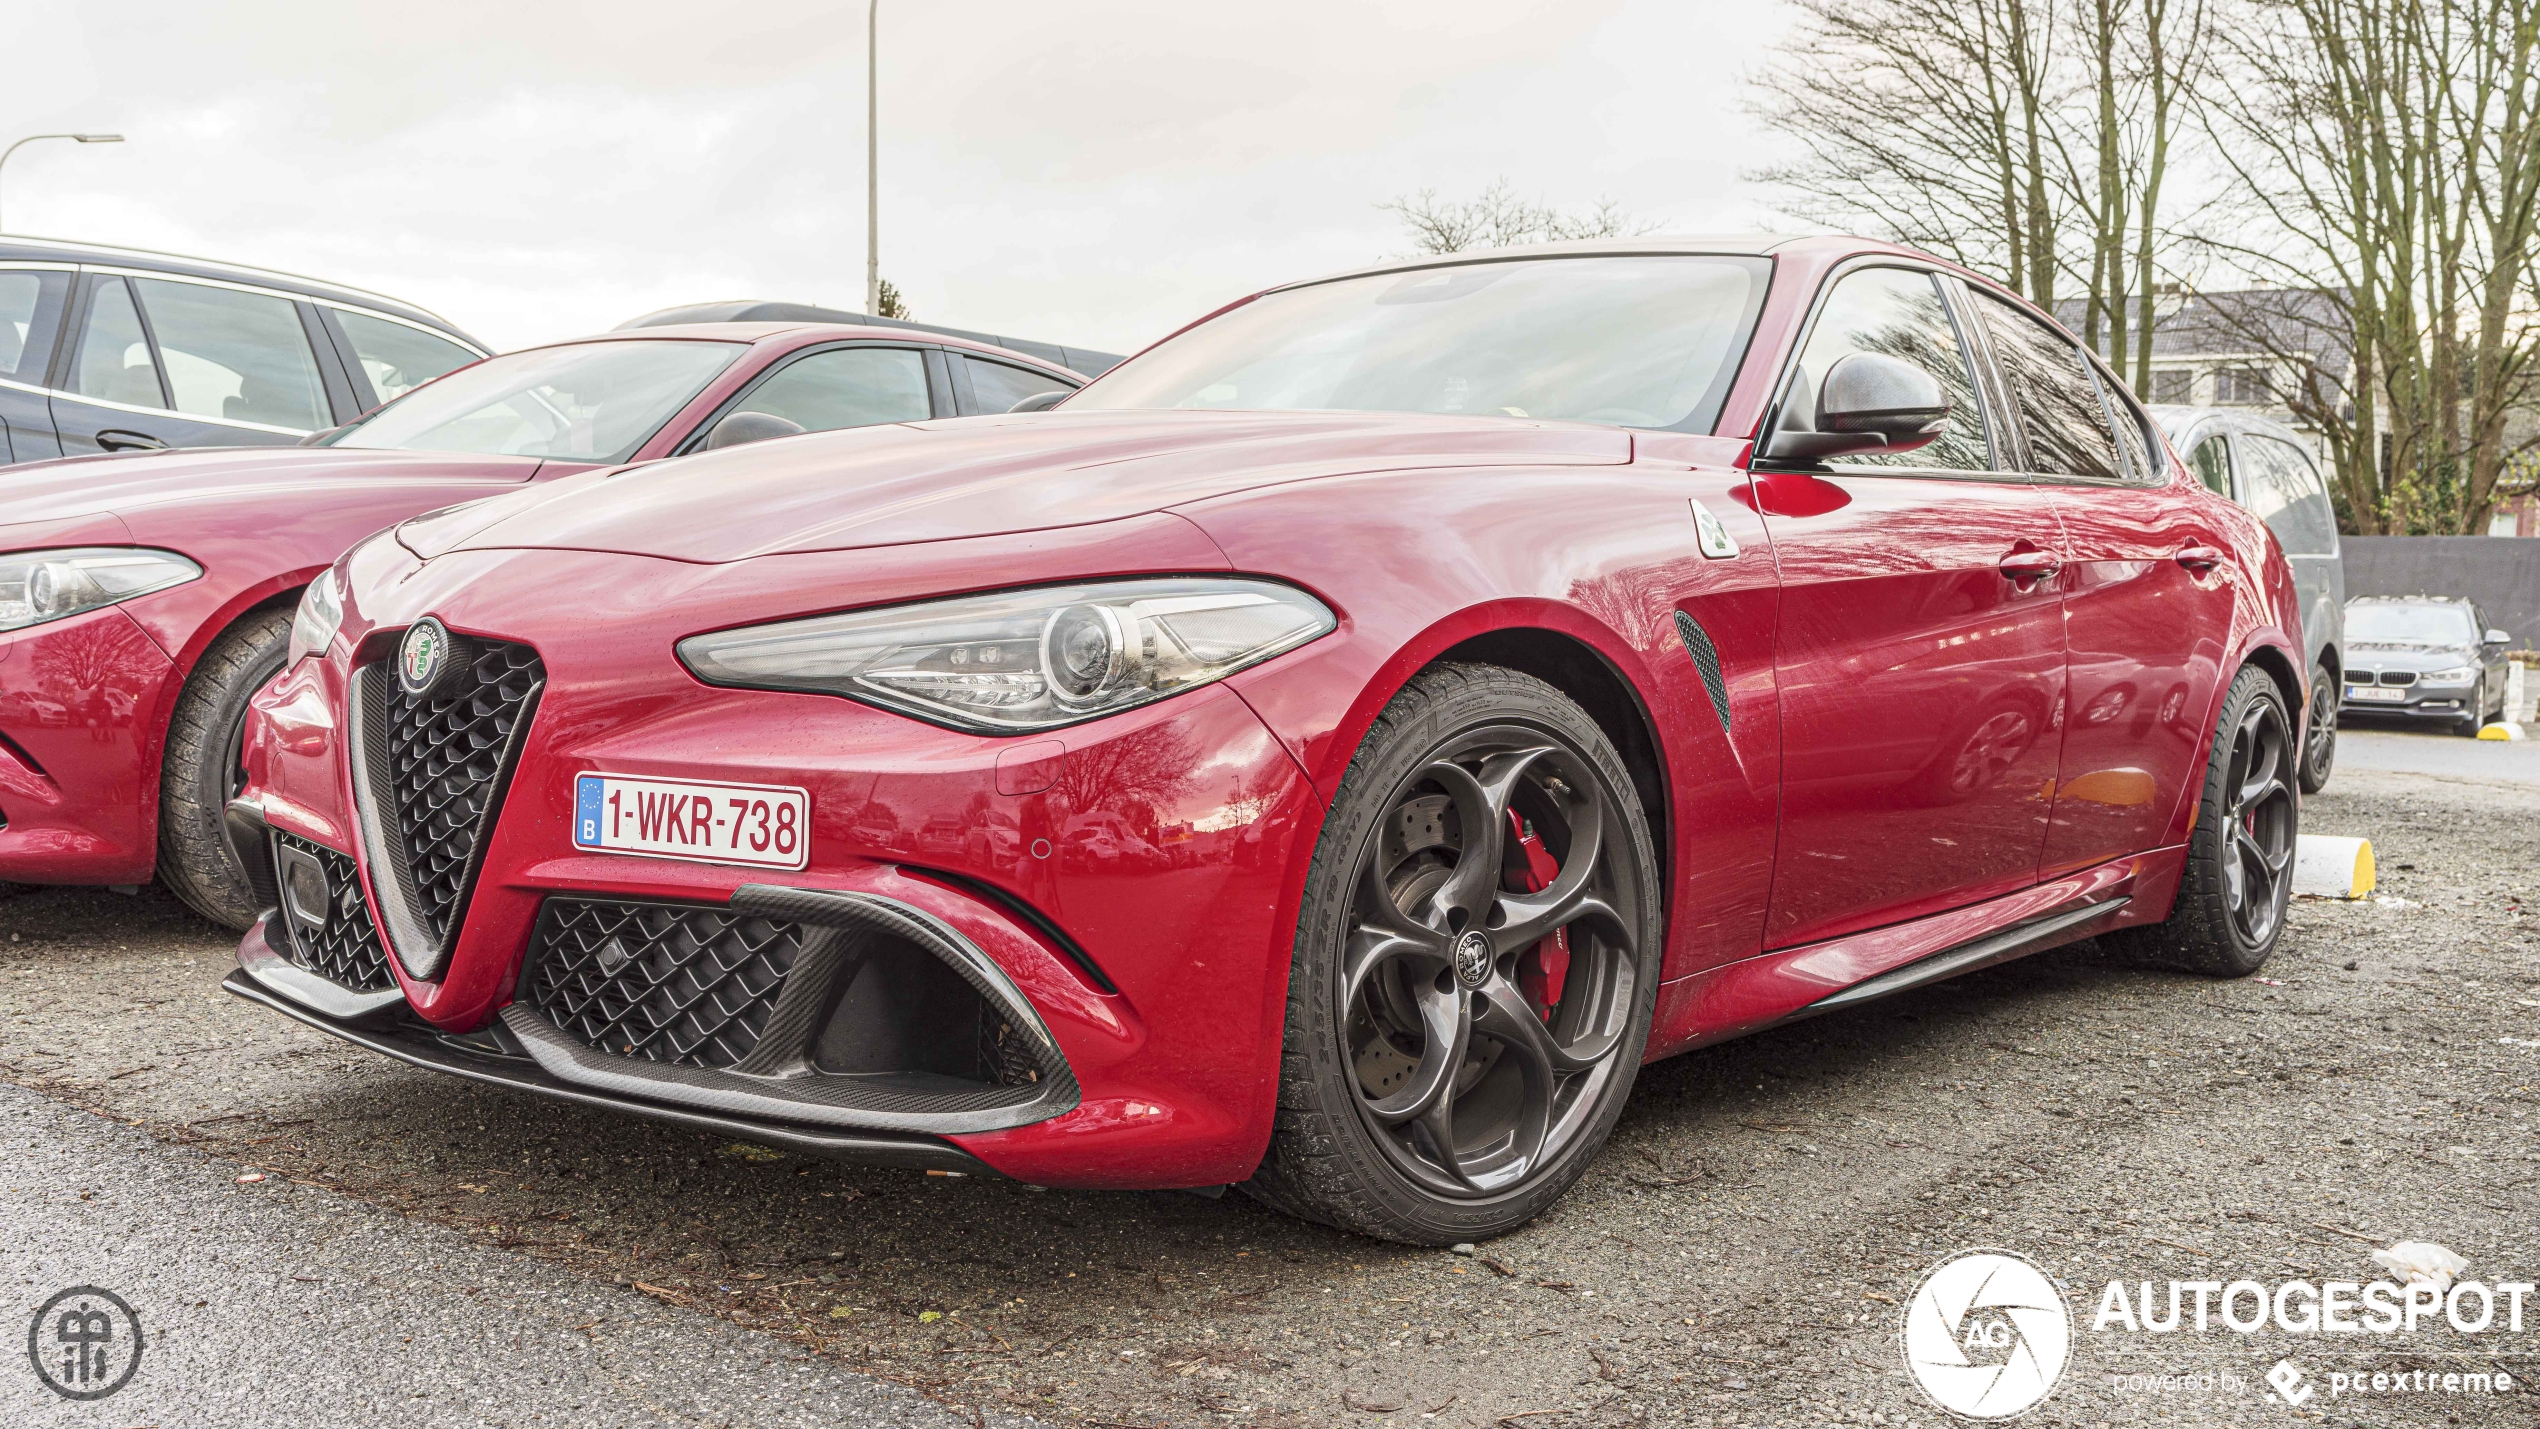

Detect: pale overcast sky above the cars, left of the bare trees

[0,0,1788,350]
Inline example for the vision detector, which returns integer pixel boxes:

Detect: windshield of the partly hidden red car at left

[328,338,747,464]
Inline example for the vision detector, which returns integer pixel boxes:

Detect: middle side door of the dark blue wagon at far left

[51,272,348,457]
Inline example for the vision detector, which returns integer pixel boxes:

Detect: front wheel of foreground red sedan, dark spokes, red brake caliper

[1245,665,1664,1246]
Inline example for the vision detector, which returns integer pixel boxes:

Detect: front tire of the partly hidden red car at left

[157,607,292,929]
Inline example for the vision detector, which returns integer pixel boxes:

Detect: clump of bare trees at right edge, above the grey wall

[2202,0,2540,533]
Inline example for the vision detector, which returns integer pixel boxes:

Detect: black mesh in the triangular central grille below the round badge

[371,637,546,954]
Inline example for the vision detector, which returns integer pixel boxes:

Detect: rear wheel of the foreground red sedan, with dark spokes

[2108,665,2301,977]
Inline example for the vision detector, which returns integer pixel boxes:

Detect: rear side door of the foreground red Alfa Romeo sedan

[1974,292,2233,878]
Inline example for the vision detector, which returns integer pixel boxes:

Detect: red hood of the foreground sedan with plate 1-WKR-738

[396,411,1631,563]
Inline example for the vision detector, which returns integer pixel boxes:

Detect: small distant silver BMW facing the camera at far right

[2342,596,2512,734]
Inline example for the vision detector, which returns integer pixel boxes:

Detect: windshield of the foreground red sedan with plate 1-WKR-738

[1067,256,1773,431]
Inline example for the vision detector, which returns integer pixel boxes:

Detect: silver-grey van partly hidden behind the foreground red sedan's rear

[2151,406,2347,794]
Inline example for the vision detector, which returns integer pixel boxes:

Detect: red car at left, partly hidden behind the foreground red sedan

[0,322,1085,929]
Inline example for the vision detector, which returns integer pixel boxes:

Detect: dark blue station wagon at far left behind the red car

[0,239,485,461]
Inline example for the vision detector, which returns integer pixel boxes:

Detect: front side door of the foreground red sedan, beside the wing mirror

[1755,264,2065,947]
